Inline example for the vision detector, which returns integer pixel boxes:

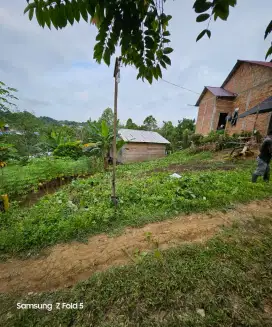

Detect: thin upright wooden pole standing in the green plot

[111,57,121,207]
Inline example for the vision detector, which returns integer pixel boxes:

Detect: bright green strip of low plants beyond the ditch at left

[0,157,101,199]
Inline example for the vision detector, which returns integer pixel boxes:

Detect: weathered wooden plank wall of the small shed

[118,143,166,163]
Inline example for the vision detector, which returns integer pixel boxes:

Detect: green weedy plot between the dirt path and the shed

[0,152,272,258]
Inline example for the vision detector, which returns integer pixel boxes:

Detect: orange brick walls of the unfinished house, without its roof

[196,63,272,135]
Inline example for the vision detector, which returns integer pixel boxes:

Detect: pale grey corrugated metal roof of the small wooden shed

[118,129,170,144]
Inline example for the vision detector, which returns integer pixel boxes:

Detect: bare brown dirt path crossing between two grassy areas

[0,199,272,293]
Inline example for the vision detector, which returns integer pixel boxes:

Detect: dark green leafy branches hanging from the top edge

[24,0,272,83]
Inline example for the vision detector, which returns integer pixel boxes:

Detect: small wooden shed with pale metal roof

[117,129,170,163]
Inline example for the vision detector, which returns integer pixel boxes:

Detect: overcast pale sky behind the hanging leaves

[0,0,272,124]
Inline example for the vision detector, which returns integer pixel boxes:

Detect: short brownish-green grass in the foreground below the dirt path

[0,216,272,327]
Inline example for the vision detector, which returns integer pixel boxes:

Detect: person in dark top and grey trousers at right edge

[252,130,272,183]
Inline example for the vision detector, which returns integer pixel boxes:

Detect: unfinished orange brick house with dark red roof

[196,60,272,135]
